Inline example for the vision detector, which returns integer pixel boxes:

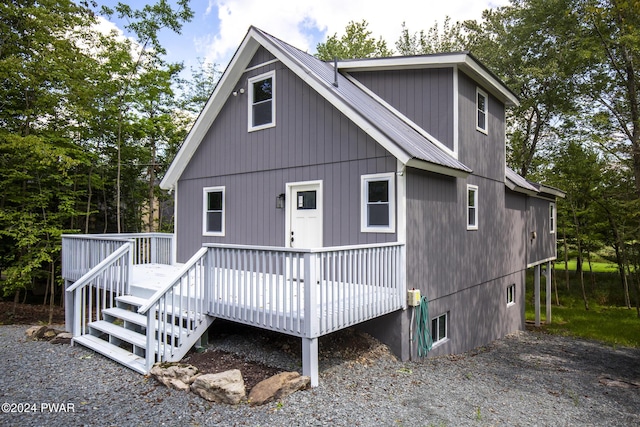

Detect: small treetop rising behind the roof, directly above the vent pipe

[315,19,393,61]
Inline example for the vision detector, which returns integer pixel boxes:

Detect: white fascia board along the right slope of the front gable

[255,30,412,164]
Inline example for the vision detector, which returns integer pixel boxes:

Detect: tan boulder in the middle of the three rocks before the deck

[191,369,246,405]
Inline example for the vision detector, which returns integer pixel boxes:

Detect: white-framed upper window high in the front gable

[248,71,276,132]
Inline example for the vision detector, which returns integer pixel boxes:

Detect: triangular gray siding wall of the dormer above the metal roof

[351,68,453,150]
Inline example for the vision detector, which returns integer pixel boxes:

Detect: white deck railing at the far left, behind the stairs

[62,233,175,282]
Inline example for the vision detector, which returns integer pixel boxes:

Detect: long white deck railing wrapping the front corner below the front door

[206,243,406,338]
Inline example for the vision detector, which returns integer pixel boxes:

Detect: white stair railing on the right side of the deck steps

[138,248,212,371]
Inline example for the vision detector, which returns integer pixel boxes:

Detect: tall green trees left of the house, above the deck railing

[0,0,193,296]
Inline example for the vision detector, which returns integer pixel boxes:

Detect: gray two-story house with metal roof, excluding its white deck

[162,28,559,358]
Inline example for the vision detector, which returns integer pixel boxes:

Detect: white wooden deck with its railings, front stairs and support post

[63,235,406,386]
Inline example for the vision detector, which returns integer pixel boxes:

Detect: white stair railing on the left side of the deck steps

[65,242,133,337]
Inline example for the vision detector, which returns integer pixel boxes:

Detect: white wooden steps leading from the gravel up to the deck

[73,264,214,374]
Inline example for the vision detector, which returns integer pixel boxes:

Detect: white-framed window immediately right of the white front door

[360,173,396,233]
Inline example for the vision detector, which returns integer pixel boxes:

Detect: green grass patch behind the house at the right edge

[525,270,640,348]
